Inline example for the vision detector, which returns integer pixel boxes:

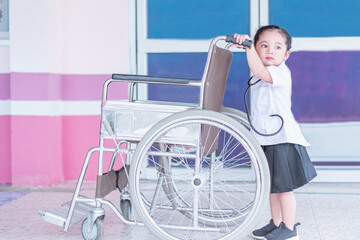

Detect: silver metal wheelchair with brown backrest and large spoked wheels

[39,36,270,240]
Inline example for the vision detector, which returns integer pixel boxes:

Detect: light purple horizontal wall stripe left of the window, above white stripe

[9,72,127,101]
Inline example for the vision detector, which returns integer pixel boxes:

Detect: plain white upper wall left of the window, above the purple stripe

[10,0,129,74]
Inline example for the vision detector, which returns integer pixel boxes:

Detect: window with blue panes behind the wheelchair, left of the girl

[138,0,250,109]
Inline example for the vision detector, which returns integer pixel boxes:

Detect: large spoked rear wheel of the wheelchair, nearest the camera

[130,110,270,239]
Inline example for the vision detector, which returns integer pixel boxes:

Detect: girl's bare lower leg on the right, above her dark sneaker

[278,192,296,230]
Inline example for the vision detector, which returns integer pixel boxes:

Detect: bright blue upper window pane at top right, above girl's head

[270,0,360,37]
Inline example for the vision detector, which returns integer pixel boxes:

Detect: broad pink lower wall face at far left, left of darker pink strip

[11,116,63,186]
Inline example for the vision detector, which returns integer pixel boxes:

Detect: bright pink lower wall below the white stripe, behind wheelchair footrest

[9,113,120,186]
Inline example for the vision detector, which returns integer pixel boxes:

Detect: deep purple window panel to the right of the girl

[287,51,360,123]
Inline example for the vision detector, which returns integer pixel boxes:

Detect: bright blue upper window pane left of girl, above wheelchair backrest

[147,0,249,39]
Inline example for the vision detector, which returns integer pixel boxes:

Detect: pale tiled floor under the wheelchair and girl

[0,182,360,240]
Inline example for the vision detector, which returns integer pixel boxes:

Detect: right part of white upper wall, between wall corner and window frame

[62,0,129,73]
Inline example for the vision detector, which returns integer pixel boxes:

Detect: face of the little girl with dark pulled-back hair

[255,29,290,67]
